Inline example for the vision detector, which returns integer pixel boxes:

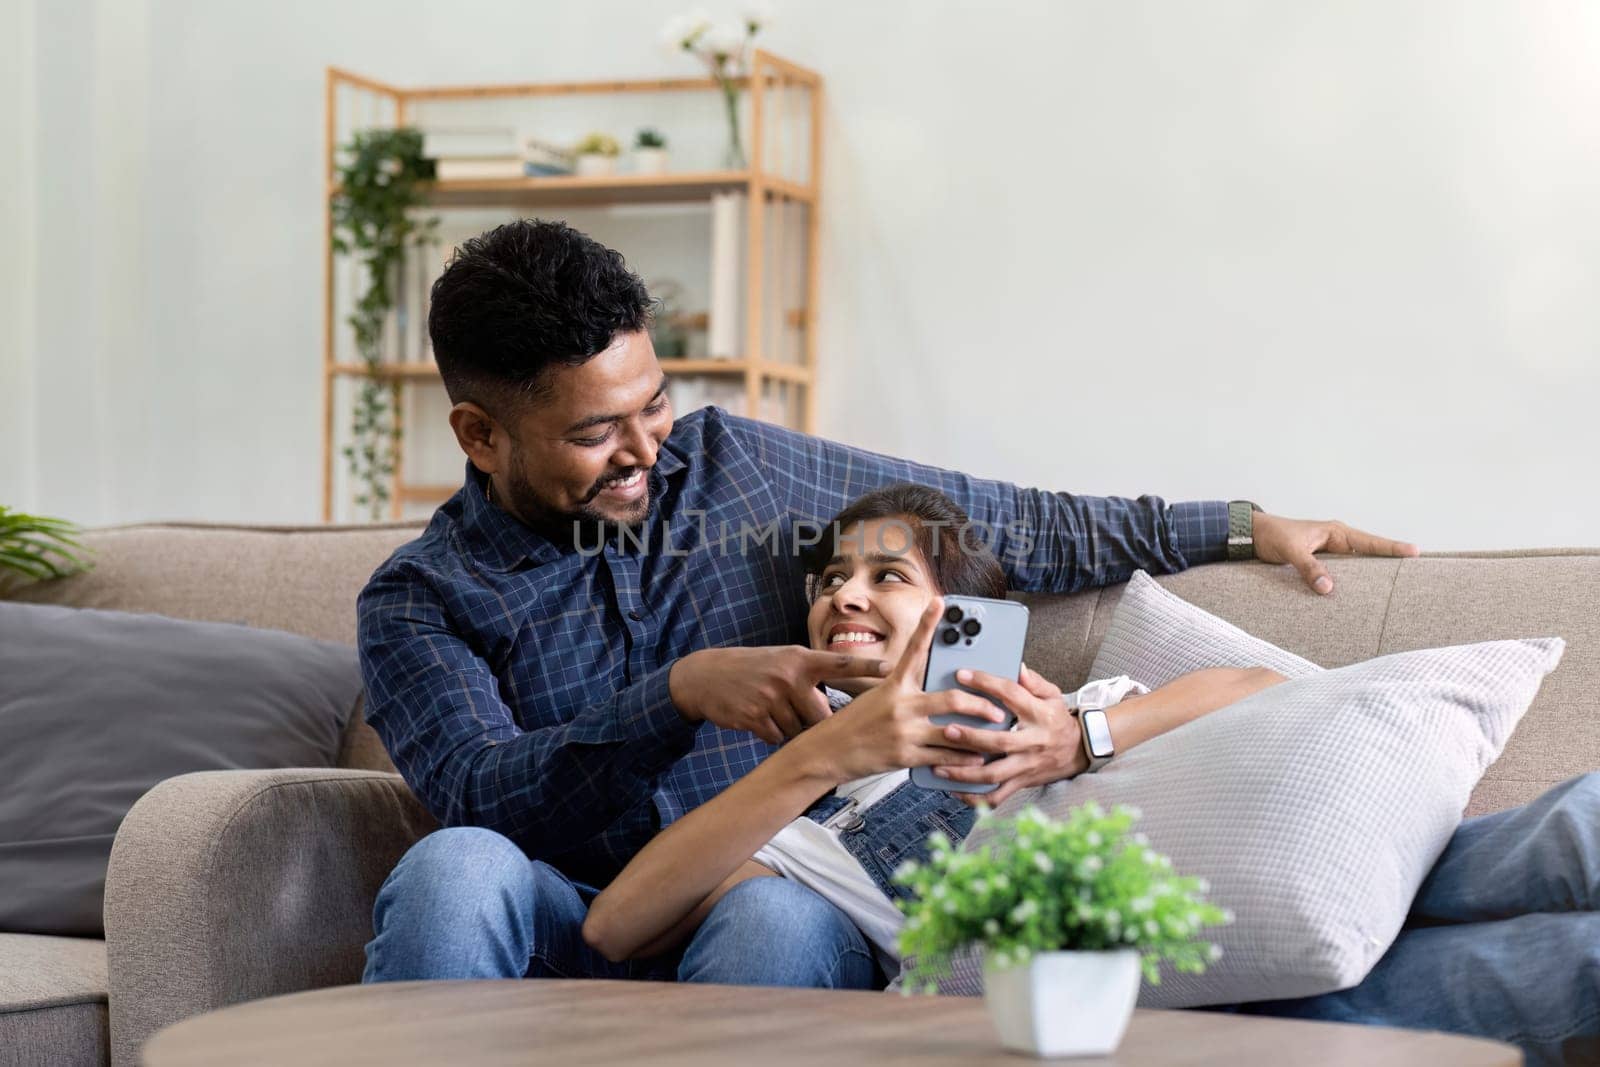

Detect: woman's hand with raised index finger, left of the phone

[786,597,1005,782]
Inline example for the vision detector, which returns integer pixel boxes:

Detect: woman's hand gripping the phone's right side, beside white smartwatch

[934,664,1086,808]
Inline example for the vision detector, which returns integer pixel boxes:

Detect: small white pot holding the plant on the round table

[984,950,1141,1057]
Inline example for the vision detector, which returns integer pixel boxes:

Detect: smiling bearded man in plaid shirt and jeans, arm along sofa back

[360,221,1416,985]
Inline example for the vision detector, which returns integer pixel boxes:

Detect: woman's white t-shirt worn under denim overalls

[752,675,1149,979]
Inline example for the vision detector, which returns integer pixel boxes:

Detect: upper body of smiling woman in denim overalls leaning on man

[584,485,1283,984]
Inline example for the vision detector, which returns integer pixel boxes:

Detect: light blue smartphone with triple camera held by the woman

[910,597,1027,793]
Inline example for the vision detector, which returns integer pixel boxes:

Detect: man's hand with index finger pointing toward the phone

[667,645,890,744]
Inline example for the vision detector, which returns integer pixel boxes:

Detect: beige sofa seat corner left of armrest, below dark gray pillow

[0,934,110,1067]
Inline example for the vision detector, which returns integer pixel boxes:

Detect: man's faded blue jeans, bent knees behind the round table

[362,827,883,989]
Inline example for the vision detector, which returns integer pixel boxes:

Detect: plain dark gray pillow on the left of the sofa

[0,603,362,936]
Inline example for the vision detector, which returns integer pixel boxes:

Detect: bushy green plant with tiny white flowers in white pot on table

[896,803,1232,1056]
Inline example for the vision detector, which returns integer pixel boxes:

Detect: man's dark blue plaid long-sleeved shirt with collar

[358,408,1227,883]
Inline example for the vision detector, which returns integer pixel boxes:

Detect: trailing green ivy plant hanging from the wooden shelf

[331,126,438,520]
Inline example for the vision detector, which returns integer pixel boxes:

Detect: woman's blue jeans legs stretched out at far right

[1234,774,1600,1064]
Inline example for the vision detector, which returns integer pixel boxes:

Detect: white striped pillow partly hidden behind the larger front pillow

[1090,571,1322,689]
